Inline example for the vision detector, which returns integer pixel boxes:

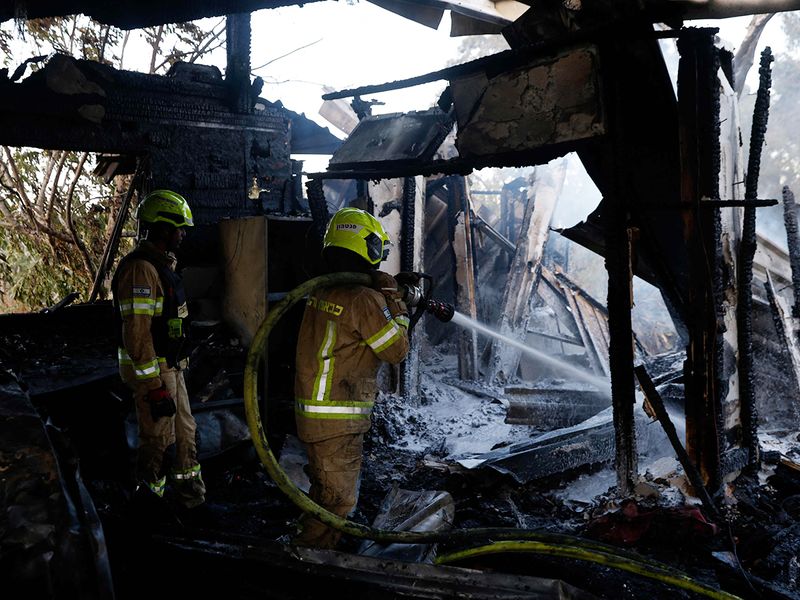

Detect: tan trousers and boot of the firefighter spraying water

[292,433,364,548]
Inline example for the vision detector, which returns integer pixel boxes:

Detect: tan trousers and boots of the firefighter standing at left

[129,368,206,508]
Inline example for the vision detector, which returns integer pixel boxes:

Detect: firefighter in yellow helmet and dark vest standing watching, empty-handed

[111,190,205,509]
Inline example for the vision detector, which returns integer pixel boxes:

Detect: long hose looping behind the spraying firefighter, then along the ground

[244,273,735,599]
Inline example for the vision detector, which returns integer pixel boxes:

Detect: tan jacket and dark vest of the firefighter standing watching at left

[111,240,188,389]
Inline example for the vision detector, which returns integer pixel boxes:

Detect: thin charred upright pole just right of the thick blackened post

[737,47,768,464]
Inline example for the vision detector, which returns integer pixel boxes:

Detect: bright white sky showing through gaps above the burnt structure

[101,1,783,138]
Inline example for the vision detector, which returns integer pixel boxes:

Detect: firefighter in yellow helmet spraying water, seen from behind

[292,208,409,548]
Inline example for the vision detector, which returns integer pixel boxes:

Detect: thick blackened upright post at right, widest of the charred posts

[678,29,726,488]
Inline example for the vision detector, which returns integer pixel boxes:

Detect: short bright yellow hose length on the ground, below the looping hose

[435,541,742,600]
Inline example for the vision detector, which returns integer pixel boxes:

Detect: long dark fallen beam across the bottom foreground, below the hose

[155,536,595,600]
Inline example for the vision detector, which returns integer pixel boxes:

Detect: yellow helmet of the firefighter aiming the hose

[322,208,390,266]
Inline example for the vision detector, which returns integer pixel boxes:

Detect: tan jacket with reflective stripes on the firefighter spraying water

[294,285,408,442]
